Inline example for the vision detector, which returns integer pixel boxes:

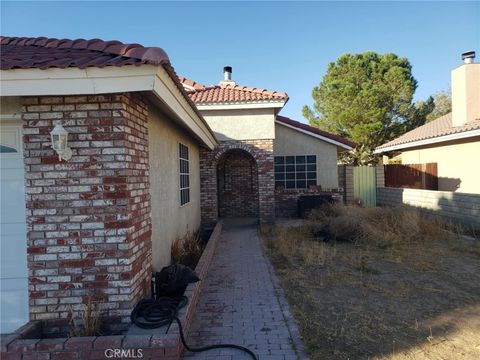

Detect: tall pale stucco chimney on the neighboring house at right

[452,51,480,126]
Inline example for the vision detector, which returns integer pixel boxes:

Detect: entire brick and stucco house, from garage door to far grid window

[0,37,353,333]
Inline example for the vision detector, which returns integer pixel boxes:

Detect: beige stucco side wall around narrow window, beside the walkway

[148,107,200,271]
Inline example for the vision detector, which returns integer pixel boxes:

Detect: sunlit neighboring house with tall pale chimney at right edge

[375,53,480,194]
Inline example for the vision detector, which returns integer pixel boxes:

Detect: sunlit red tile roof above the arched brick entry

[180,77,288,105]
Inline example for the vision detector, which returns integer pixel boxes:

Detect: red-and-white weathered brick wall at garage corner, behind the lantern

[22,94,151,330]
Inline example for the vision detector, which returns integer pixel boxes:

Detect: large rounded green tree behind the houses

[303,52,433,164]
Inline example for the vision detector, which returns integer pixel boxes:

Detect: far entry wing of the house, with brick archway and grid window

[180,66,354,224]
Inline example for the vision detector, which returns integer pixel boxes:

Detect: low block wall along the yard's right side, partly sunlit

[377,187,480,229]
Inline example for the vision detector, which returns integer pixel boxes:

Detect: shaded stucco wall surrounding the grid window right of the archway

[273,124,338,189]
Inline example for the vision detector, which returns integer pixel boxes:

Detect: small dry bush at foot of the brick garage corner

[69,297,101,337]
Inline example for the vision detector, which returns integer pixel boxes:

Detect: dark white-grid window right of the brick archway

[275,155,317,189]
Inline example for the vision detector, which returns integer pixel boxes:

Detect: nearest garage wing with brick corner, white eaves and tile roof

[0,37,217,333]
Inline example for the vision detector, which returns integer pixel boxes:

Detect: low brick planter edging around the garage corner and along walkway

[0,223,222,360]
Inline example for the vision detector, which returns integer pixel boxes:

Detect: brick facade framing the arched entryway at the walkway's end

[200,139,275,226]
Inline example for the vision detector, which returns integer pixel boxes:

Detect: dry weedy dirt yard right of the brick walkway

[260,206,480,360]
